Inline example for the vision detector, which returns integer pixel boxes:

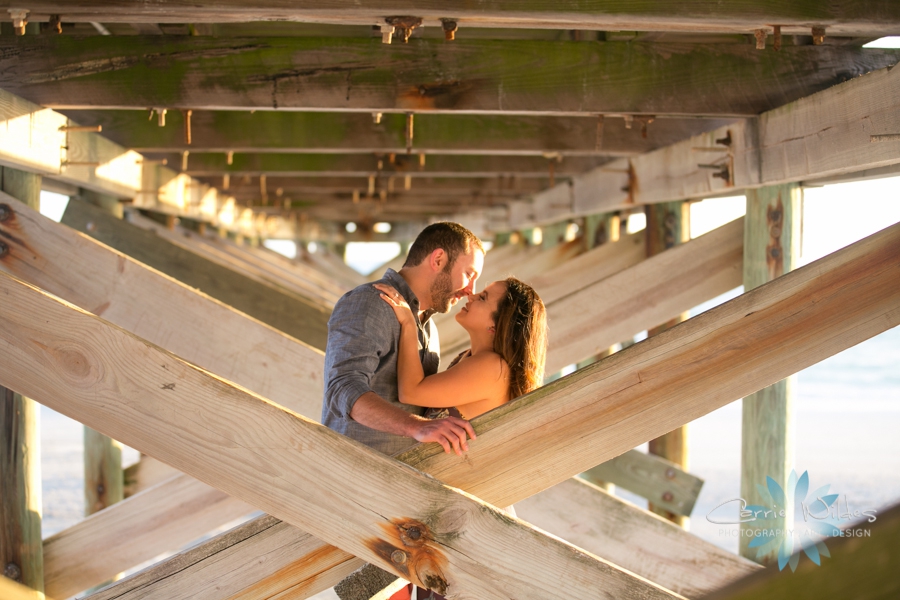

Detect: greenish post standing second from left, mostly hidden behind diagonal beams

[81,190,125,517]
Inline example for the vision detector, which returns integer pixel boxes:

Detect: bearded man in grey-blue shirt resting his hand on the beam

[322,223,484,455]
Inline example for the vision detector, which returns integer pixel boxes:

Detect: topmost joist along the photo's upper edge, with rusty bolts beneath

[7,0,900,36]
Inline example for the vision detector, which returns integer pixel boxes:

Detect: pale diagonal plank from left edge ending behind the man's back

[0,195,325,419]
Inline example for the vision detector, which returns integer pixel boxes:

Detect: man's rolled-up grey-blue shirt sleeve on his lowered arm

[322,288,400,424]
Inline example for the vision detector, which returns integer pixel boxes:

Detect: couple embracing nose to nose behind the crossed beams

[322,223,547,597]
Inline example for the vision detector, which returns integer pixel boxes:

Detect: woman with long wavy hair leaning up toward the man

[375,277,547,419]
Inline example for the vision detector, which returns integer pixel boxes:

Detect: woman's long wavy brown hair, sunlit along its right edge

[493,277,547,399]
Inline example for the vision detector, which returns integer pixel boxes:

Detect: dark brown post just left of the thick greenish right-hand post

[644,201,691,529]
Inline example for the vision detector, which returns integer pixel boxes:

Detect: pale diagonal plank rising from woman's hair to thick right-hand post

[547,219,744,376]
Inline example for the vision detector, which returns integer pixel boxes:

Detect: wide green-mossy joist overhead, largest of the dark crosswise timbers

[0,36,900,116]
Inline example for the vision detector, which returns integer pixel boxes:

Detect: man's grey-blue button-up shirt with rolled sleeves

[322,269,441,455]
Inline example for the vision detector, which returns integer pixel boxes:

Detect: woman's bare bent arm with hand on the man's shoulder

[375,285,509,412]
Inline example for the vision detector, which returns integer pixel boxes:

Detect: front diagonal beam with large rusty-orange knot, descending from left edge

[0,274,680,599]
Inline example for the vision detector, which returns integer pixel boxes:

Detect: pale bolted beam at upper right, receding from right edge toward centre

[472,63,900,233]
